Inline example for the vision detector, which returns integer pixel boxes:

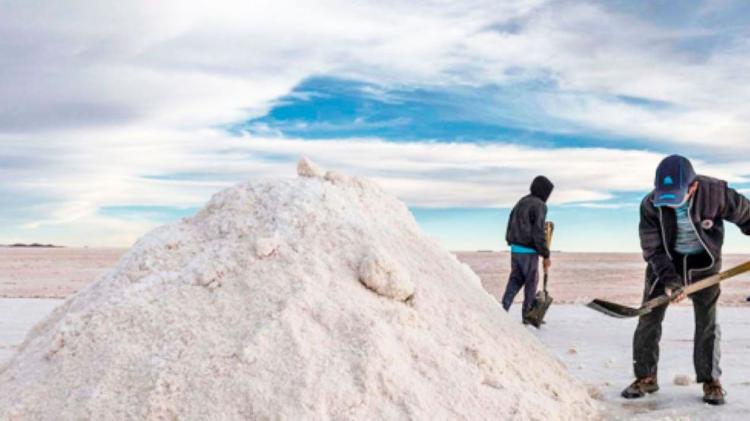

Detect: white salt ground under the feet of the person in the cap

[512,305,750,420]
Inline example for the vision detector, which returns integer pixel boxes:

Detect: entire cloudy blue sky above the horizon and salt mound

[0,0,750,251]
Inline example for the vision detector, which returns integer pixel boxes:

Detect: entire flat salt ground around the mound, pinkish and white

[0,249,750,420]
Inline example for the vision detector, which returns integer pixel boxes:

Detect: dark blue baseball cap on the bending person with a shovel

[654,155,695,206]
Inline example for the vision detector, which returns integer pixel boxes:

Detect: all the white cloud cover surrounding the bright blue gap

[0,0,750,244]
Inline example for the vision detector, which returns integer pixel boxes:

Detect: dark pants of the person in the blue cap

[633,251,721,383]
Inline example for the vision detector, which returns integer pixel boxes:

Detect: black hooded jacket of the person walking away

[505,176,554,258]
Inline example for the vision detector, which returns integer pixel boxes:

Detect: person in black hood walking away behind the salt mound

[502,175,554,324]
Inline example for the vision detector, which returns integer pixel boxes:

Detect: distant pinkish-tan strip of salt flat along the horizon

[0,248,750,305]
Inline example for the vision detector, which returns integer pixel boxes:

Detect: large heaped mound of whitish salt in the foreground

[0,161,598,420]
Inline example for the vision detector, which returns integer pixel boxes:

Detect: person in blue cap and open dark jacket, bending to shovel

[622,155,750,405]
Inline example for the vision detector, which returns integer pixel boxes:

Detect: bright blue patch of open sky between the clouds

[234,76,669,149]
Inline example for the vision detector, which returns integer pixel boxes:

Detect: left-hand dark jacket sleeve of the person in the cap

[638,198,682,288]
